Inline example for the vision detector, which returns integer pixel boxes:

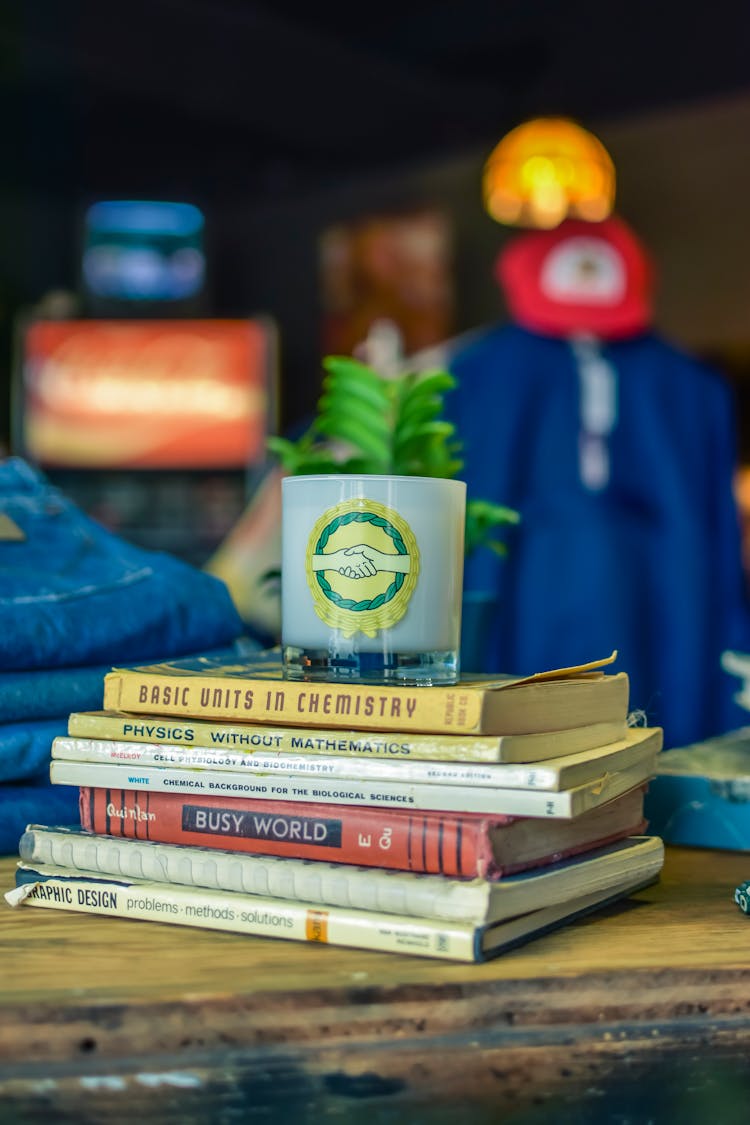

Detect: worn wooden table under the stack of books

[0,849,750,1125]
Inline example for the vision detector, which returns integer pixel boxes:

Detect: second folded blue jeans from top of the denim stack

[0,637,260,732]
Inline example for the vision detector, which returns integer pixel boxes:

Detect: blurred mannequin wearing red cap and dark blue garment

[449,217,750,747]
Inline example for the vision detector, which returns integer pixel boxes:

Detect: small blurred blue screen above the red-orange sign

[82,199,206,303]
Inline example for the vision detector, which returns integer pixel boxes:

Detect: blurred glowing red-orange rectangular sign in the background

[18,318,275,469]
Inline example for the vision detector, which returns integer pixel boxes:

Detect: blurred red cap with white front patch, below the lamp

[495,216,653,340]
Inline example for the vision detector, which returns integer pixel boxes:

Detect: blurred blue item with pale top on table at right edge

[649,727,750,852]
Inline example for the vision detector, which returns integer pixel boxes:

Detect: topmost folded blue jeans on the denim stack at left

[0,457,243,671]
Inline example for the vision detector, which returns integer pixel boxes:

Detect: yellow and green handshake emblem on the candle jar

[305,497,419,637]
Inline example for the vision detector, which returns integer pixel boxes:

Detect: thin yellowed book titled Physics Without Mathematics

[67,711,627,763]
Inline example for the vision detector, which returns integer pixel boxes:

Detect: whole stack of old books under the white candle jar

[6,651,663,961]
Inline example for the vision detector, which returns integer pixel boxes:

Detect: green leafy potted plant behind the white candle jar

[268,356,519,668]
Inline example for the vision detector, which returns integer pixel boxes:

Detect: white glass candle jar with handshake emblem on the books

[281,475,466,684]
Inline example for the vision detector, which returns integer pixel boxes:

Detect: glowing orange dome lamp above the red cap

[482,117,615,230]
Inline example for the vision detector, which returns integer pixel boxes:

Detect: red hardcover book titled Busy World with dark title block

[79,785,645,879]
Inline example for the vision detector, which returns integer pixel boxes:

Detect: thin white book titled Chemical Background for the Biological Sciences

[49,727,661,818]
